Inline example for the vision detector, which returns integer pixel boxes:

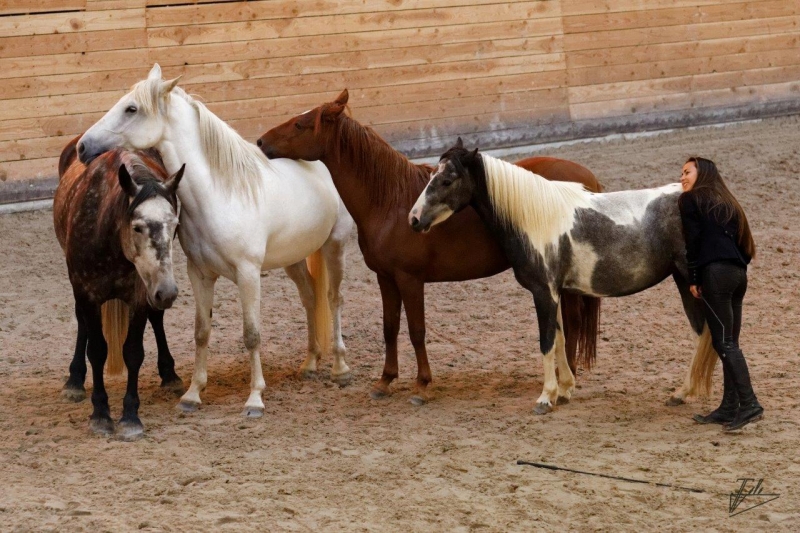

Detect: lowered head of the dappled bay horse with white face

[119,163,186,309]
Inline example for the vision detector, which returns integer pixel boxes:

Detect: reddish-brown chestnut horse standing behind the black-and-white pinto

[257,90,601,404]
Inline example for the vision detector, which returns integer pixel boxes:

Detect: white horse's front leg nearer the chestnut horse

[236,265,266,418]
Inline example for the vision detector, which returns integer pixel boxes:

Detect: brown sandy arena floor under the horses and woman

[0,117,800,531]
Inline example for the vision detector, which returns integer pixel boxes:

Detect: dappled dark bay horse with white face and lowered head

[53,138,183,439]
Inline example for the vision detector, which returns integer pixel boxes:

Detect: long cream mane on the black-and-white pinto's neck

[481,154,589,251]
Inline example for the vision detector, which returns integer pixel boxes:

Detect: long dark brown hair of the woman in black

[684,157,756,257]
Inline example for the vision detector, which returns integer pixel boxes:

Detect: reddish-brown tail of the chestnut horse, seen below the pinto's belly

[561,293,600,370]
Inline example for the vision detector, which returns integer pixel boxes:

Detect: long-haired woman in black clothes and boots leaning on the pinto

[679,157,764,431]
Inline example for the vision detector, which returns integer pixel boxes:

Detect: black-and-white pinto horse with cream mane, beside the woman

[409,138,717,414]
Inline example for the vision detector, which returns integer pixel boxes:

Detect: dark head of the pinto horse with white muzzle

[408,137,480,233]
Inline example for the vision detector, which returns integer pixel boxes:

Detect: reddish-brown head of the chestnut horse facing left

[256,89,349,161]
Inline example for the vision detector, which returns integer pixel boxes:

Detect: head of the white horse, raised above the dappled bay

[78,64,179,164]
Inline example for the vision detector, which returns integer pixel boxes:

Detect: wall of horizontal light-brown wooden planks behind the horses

[0,0,800,201]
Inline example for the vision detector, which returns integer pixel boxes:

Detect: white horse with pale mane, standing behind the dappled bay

[78,64,353,417]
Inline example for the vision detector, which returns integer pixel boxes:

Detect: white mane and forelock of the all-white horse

[133,79,269,198]
